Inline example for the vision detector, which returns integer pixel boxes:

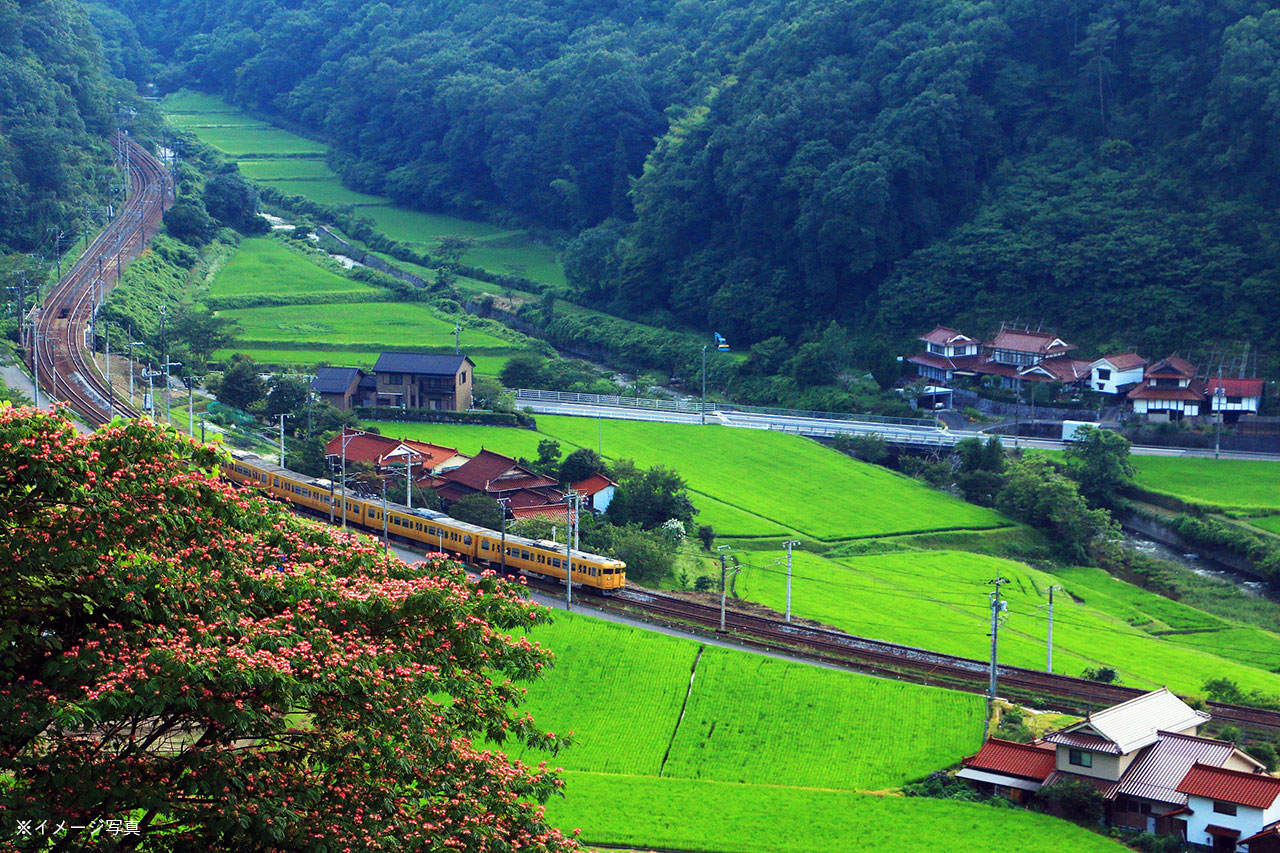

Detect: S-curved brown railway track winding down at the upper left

[27,137,172,427]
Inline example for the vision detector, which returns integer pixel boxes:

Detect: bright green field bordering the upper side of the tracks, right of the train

[736,551,1280,694]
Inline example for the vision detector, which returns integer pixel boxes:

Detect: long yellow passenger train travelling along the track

[223,451,627,594]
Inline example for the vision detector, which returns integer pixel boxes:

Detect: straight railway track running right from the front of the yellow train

[591,589,1280,731]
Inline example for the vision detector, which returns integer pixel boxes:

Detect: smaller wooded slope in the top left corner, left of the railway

[0,0,119,252]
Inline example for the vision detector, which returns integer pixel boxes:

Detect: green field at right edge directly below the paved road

[1132,456,1280,510]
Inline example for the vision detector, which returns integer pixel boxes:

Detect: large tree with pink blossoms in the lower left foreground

[0,409,579,852]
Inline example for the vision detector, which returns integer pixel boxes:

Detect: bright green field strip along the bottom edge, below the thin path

[547,772,1129,853]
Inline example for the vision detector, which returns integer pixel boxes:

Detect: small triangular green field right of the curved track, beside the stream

[209,237,375,298]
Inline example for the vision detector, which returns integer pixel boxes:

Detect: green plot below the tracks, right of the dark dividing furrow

[663,648,983,790]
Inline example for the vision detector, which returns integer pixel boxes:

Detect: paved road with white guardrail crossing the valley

[517,400,1280,462]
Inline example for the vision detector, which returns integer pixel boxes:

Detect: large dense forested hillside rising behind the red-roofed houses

[94,0,1280,355]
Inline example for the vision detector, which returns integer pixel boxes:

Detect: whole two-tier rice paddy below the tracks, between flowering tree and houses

[514,613,1123,853]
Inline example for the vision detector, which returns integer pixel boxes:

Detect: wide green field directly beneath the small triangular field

[218,302,520,352]
